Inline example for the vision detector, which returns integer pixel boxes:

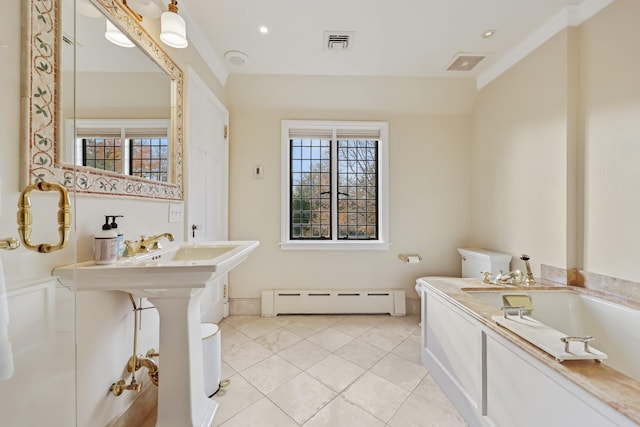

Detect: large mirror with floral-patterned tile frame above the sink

[22,0,184,200]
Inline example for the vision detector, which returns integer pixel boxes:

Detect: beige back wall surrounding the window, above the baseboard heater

[227,76,475,298]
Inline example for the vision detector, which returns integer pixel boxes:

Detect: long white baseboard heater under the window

[262,289,407,317]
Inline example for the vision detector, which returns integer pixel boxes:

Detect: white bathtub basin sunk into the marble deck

[466,288,640,381]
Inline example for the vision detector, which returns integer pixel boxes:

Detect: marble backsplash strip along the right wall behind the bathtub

[540,264,640,303]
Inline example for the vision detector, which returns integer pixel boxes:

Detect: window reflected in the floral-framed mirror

[73,120,170,182]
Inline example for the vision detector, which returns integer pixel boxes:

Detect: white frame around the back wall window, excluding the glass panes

[280,120,391,250]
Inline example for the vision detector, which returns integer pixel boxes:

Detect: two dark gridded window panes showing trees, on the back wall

[290,138,378,240]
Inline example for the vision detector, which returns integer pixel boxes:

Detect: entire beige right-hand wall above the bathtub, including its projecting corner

[470,0,640,281]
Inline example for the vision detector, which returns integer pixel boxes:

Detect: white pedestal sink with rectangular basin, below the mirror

[53,241,260,427]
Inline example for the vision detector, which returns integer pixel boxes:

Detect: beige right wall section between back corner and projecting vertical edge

[470,31,572,274]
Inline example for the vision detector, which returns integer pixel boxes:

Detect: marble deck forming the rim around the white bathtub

[420,277,640,425]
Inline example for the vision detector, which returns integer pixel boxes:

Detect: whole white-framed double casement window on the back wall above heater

[281,120,389,249]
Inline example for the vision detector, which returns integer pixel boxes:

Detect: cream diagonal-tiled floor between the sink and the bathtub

[214,315,466,427]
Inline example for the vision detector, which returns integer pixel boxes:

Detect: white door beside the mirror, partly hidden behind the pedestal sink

[185,68,229,323]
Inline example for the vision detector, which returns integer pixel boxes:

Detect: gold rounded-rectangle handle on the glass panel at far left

[18,181,71,254]
